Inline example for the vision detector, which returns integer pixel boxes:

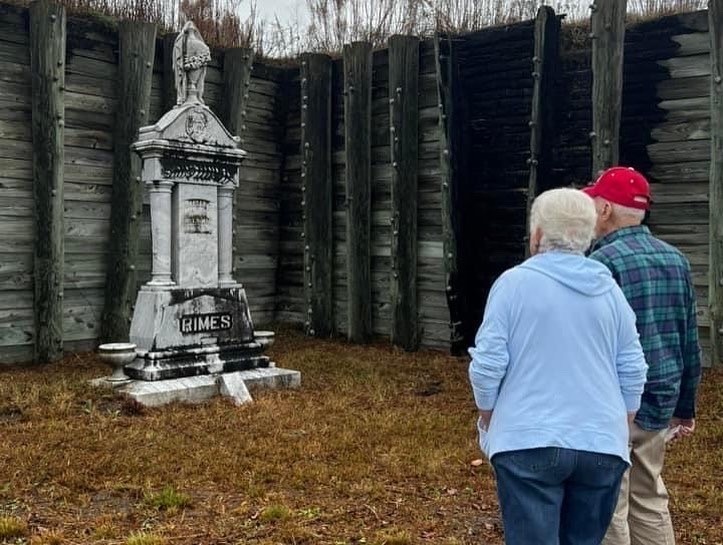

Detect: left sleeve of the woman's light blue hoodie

[469,275,511,411]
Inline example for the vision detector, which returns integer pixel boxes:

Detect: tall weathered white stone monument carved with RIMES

[104,22,299,404]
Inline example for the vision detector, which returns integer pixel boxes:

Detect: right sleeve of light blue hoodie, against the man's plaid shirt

[615,287,648,413]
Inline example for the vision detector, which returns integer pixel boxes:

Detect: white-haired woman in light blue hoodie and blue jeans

[469,189,647,545]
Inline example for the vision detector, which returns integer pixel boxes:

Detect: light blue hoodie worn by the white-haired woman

[469,252,647,463]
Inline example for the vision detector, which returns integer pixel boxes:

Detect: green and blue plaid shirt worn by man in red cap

[590,225,701,430]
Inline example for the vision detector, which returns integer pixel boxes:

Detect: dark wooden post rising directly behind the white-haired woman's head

[525,6,560,257]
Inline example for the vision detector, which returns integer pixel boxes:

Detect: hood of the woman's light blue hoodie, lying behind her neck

[519,252,615,297]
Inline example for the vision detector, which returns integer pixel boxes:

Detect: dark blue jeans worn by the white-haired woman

[492,447,628,545]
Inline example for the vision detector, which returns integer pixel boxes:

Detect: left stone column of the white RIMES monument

[148,180,174,286]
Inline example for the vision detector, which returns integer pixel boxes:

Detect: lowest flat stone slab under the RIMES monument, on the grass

[91,367,301,407]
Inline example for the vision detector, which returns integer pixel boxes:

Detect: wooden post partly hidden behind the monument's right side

[221,47,254,281]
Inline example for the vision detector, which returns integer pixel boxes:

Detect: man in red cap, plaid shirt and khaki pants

[584,167,701,545]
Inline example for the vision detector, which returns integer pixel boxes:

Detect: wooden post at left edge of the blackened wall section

[434,34,464,352]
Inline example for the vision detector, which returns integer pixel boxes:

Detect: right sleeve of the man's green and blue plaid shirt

[673,274,701,420]
